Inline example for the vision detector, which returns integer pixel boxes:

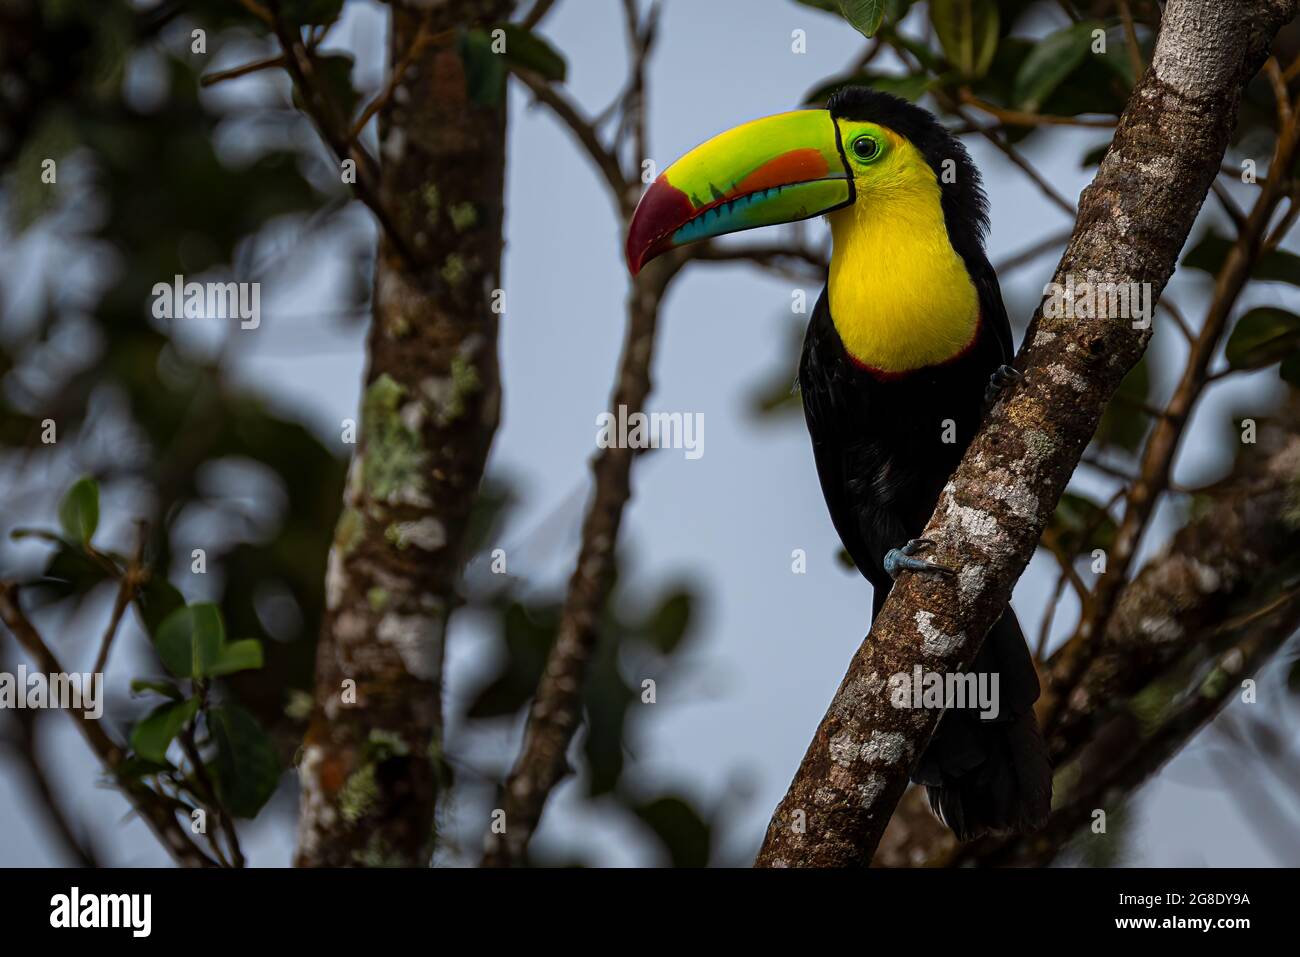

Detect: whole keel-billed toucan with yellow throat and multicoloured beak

[627,88,1052,839]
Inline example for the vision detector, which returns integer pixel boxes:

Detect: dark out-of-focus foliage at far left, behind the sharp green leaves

[0,0,345,755]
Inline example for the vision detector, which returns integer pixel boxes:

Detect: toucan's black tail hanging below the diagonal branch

[913,609,1052,841]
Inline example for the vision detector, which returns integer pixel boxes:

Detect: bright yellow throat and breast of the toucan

[828,130,979,373]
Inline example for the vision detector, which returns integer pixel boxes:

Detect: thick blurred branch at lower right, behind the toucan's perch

[872,407,1300,867]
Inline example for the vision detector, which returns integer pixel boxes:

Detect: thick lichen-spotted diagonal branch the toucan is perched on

[755,0,1296,867]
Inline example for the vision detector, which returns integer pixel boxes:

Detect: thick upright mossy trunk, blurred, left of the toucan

[296,0,512,866]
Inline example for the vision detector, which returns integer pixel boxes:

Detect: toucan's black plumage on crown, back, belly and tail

[800,88,1052,840]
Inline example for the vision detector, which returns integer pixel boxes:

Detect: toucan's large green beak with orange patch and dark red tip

[628,109,853,276]
